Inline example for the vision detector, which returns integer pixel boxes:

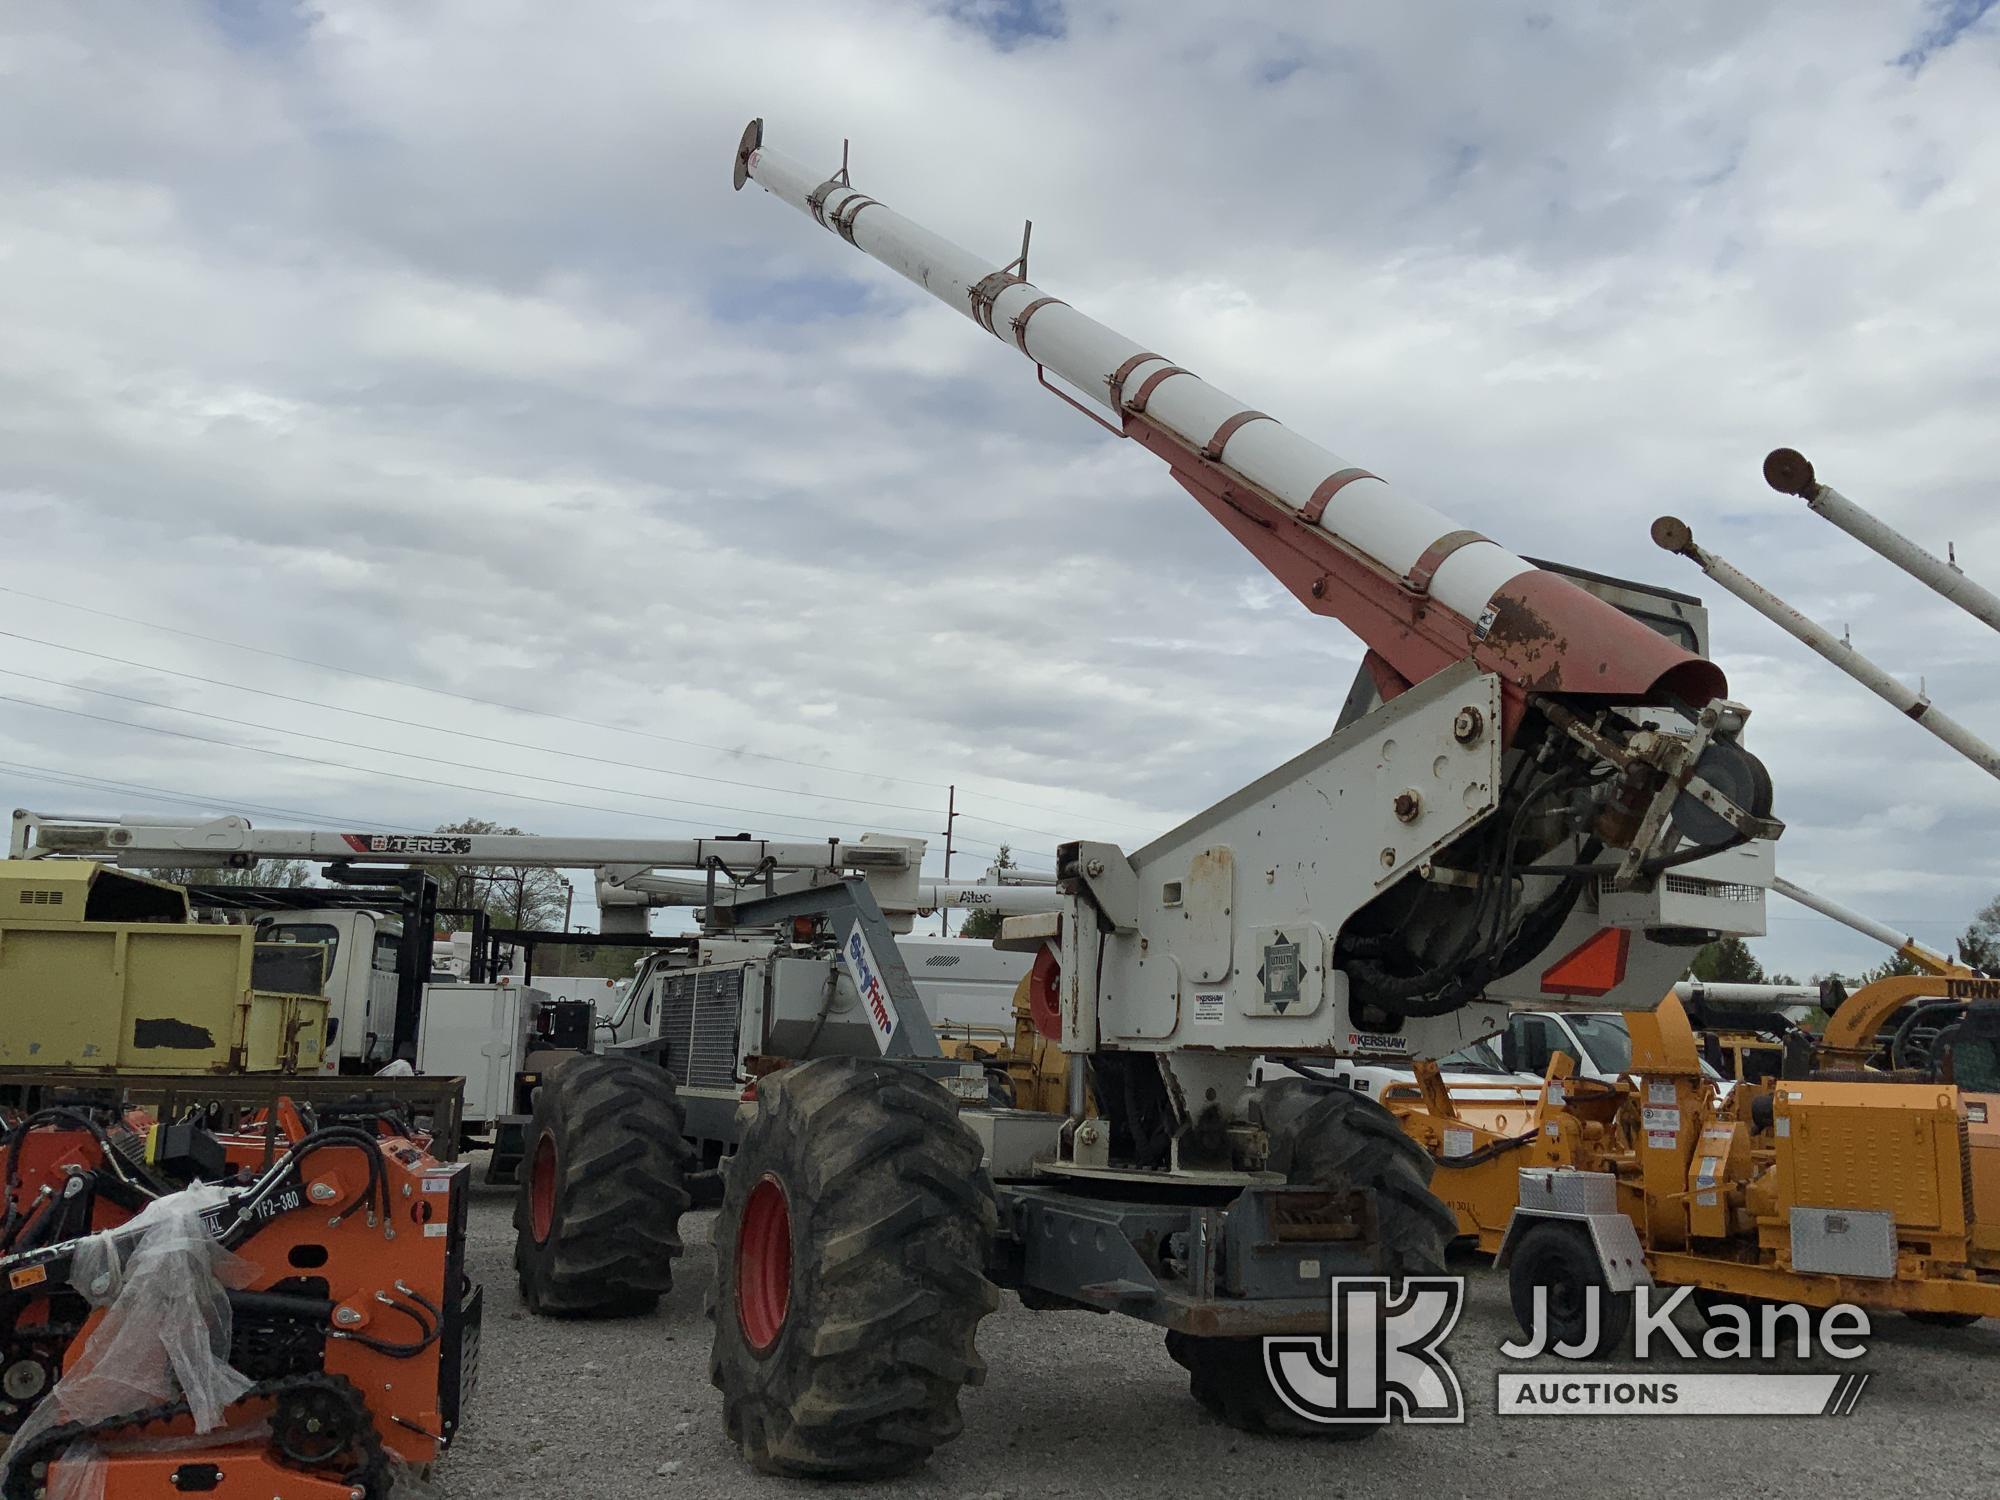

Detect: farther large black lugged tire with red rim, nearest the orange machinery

[514,1054,694,1318]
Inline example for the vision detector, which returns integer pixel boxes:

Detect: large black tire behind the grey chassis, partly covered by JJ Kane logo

[1166,1078,1458,1442]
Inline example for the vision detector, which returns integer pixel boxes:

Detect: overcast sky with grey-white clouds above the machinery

[0,0,2000,974]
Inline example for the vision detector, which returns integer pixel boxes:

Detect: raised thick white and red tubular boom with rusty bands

[736,120,1728,730]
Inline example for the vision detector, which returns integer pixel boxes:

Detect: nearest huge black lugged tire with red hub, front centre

[708,1058,998,1478]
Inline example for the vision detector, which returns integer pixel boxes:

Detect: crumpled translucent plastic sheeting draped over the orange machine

[0,1184,254,1500]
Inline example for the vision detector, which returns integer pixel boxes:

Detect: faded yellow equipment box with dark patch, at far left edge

[0,860,326,1076]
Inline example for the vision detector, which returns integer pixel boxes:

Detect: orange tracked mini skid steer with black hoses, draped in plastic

[0,1102,480,1500]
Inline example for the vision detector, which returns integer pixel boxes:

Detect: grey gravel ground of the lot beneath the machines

[436,1184,2000,1500]
